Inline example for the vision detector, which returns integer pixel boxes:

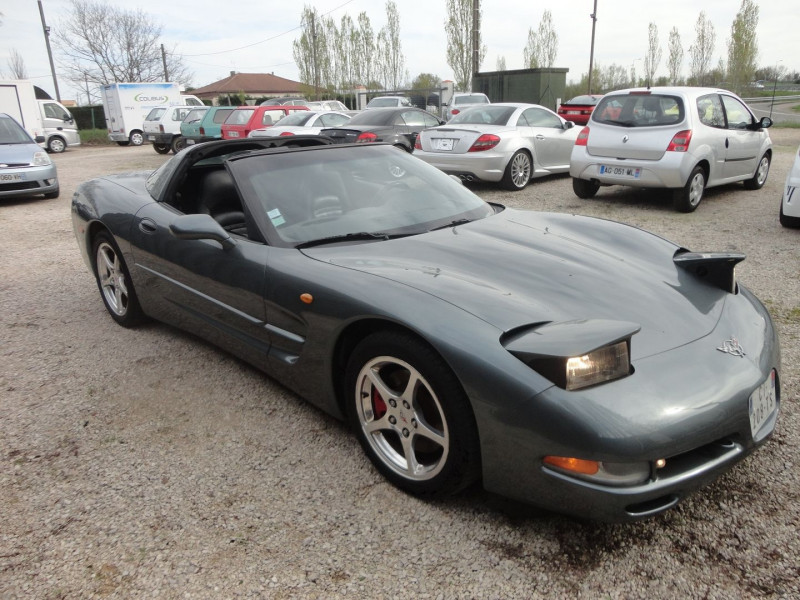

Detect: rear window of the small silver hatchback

[592,92,685,127]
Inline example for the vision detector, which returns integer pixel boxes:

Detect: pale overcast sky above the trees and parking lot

[0,0,800,99]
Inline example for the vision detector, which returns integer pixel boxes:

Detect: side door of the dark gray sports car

[131,202,270,368]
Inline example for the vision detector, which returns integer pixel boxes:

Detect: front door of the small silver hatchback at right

[721,94,763,179]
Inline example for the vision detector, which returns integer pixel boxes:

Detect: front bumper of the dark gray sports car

[475,288,780,522]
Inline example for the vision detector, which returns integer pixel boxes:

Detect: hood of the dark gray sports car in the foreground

[304,209,726,358]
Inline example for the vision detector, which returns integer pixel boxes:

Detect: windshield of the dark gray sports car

[229,146,493,246]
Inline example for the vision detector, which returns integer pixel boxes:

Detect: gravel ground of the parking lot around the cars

[0,129,800,599]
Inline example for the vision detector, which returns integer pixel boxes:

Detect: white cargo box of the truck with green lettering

[101,81,202,146]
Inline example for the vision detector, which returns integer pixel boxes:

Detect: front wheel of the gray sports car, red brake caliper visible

[345,332,480,496]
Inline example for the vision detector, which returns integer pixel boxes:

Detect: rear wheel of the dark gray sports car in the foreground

[92,231,144,327]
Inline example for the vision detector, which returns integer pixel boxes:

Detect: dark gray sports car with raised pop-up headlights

[72,136,780,520]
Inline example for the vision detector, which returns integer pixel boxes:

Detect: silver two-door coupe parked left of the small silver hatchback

[414,103,578,191]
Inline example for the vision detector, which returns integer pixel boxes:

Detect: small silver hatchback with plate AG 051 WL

[569,87,772,212]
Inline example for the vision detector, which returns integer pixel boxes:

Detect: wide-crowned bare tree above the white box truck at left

[55,0,192,85]
